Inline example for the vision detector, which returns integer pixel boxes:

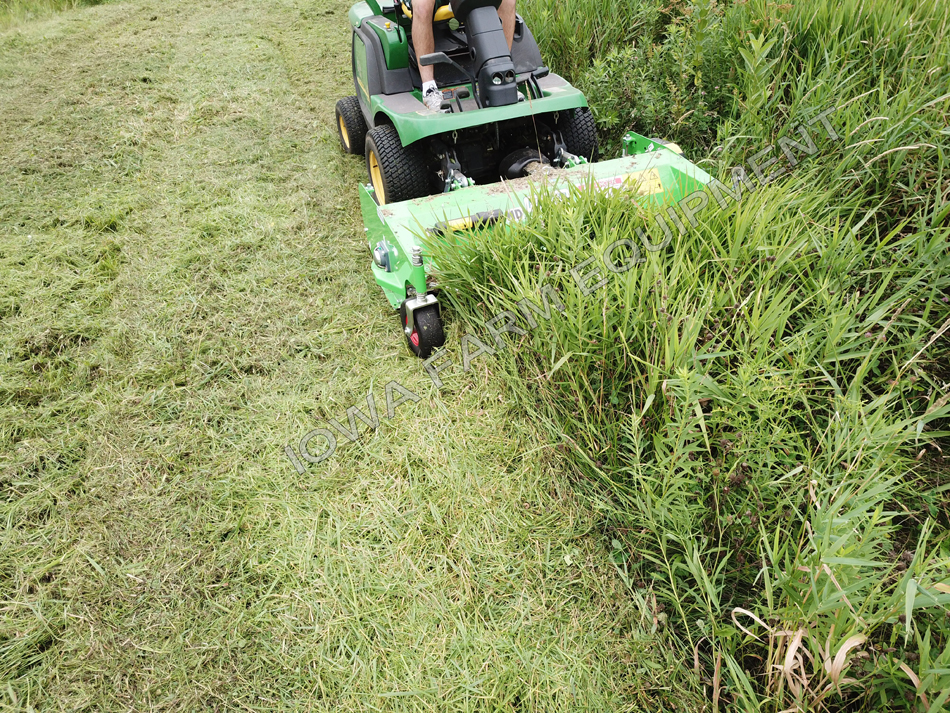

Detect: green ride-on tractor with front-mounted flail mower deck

[336,0,709,358]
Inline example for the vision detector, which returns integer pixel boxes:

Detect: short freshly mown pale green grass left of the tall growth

[0,0,702,711]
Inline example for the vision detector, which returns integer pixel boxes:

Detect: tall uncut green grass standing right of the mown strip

[434,2,950,711]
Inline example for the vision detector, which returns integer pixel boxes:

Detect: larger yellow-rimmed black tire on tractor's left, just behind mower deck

[366,124,429,205]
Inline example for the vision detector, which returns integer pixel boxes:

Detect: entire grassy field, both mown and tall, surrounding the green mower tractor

[0,0,950,713]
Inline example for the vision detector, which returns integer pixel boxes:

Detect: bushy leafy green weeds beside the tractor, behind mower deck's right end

[523,0,748,154]
